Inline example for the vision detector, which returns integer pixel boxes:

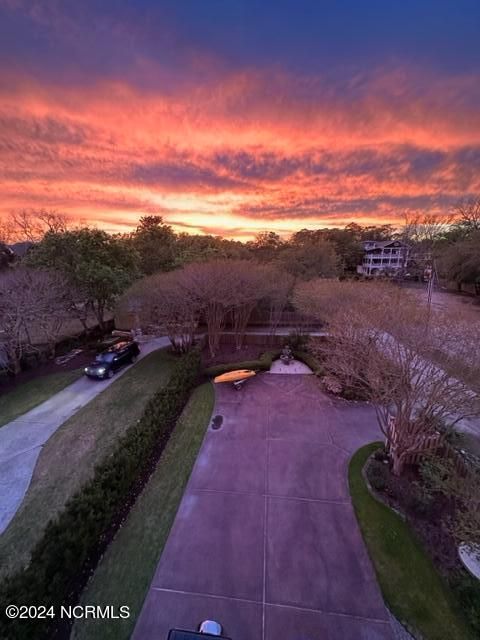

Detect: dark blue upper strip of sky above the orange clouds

[0,0,480,85]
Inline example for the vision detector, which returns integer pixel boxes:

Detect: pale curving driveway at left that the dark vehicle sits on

[0,338,169,534]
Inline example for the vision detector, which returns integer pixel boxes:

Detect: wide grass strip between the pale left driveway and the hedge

[0,349,175,577]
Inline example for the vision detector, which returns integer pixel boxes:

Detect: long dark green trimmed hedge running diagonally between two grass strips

[0,351,200,640]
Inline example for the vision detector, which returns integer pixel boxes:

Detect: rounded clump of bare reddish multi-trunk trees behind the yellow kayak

[119,260,291,356]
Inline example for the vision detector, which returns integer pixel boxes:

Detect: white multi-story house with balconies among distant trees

[357,240,409,277]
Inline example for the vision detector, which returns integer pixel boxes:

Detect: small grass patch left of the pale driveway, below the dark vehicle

[0,369,82,427]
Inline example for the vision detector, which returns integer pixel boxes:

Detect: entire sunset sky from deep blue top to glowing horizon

[0,0,480,239]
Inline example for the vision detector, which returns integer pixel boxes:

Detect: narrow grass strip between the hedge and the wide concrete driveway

[70,383,214,640]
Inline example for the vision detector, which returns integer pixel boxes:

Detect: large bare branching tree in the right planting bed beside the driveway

[294,280,480,475]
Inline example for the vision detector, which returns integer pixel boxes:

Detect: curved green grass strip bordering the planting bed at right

[349,443,473,640]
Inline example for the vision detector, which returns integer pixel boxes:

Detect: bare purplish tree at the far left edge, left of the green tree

[0,267,71,375]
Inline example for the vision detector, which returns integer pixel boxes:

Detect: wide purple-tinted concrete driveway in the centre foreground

[133,374,392,640]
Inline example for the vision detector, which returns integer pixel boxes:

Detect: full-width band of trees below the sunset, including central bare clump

[0,199,480,374]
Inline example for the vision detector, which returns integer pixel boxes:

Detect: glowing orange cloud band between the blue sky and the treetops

[0,60,480,237]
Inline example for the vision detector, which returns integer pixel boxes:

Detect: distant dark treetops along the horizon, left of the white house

[0,210,394,277]
